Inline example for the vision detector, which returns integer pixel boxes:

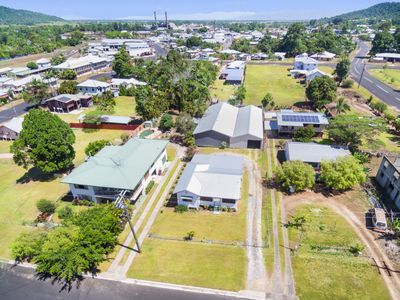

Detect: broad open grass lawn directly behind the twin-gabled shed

[244,65,305,106]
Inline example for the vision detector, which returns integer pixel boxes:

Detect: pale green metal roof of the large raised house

[61,138,168,190]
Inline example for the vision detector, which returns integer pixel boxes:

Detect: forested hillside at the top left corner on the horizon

[0,6,64,25]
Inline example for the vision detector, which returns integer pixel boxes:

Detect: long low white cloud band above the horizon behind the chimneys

[121,11,257,20]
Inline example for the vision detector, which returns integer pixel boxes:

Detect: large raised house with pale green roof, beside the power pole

[61,138,168,203]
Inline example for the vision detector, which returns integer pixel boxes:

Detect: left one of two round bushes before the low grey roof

[275,160,315,192]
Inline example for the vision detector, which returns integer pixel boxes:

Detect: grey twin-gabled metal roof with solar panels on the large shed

[194,102,263,139]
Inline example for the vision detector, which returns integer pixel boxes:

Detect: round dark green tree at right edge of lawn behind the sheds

[306,76,337,108]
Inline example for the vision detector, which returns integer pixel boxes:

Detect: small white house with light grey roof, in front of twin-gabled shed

[174,154,243,210]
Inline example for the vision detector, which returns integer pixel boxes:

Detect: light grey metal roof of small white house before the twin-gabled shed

[174,154,243,199]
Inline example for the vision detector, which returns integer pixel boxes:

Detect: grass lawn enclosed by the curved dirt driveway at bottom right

[289,205,390,299]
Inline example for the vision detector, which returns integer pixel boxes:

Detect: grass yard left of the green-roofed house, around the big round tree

[0,129,126,258]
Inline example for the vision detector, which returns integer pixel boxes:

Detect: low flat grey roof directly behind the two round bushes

[285,142,351,163]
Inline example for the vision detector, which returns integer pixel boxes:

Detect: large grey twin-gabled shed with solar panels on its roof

[193,102,264,149]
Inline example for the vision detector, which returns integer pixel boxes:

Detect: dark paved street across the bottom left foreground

[0,267,244,300]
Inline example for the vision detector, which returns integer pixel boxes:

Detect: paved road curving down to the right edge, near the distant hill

[350,42,400,109]
